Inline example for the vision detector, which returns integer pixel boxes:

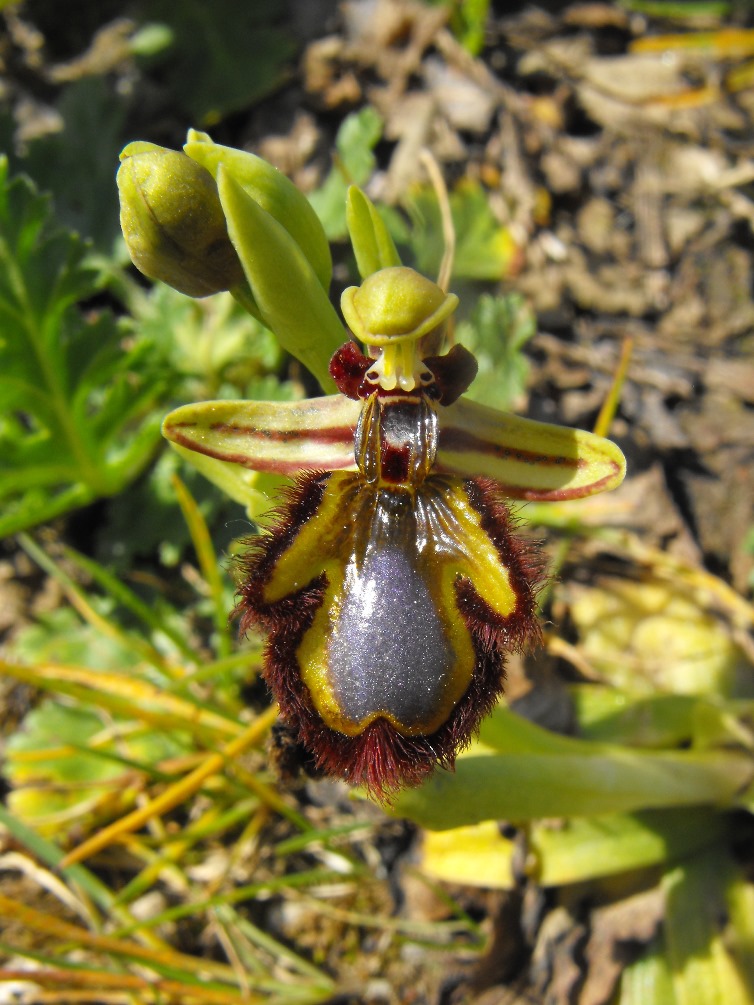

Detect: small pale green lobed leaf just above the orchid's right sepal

[455,293,537,410]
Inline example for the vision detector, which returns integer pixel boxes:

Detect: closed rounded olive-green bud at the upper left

[118,143,245,296]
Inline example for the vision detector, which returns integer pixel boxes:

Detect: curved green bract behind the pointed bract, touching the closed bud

[183,130,333,290]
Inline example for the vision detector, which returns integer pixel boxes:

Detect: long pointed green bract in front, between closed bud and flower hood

[217,164,345,391]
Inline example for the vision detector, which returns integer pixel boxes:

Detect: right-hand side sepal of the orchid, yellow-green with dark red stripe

[437,399,625,503]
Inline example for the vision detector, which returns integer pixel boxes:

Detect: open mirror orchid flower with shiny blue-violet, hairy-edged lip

[118,133,624,799]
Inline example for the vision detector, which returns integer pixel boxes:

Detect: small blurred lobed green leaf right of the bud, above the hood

[309,105,384,240]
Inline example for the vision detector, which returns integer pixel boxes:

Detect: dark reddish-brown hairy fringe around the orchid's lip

[236,474,544,802]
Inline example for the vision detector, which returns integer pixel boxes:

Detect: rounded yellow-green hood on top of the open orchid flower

[341,265,458,346]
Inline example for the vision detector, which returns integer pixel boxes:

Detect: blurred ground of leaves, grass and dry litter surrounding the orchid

[0,0,754,1005]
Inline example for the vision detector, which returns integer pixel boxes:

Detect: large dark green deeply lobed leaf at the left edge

[0,160,167,535]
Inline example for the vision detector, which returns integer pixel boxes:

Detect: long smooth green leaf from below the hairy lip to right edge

[392,709,751,830]
